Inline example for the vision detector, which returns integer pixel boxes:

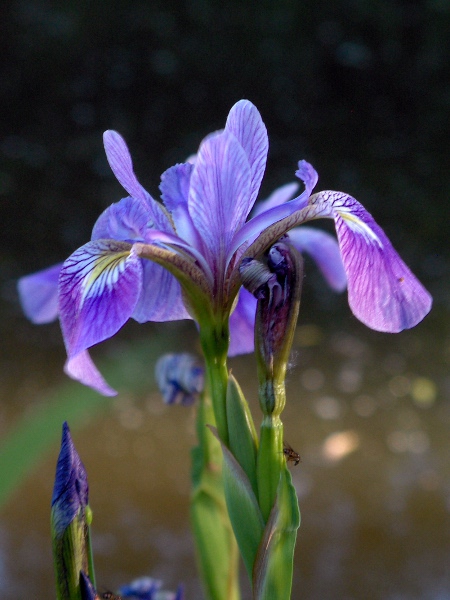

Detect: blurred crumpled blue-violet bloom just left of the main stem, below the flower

[155,353,204,406]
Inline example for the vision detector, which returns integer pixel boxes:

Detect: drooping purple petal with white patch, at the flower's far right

[315,191,432,333]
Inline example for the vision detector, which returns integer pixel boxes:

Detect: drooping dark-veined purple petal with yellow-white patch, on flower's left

[59,240,142,358]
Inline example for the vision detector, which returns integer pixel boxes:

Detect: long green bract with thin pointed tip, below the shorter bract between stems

[209,426,264,578]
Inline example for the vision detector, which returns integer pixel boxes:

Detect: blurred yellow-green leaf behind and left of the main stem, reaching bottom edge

[190,397,240,600]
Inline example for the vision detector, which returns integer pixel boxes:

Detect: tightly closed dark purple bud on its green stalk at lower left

[51,423,93,600]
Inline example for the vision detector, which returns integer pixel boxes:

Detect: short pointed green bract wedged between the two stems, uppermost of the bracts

[227,375,258,496]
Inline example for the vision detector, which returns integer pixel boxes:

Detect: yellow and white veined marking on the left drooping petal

[81,251,130,304]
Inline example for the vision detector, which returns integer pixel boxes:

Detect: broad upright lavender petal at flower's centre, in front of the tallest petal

[189,131,250,272]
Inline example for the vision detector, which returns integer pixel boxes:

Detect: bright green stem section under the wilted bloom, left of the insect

[256,416,286,522]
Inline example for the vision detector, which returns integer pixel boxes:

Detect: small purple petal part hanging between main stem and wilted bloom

[228,287,257,356]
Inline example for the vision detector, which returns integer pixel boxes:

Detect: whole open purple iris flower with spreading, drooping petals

[19,100,432,395]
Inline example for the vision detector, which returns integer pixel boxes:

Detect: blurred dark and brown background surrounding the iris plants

[0,0,450,600]
